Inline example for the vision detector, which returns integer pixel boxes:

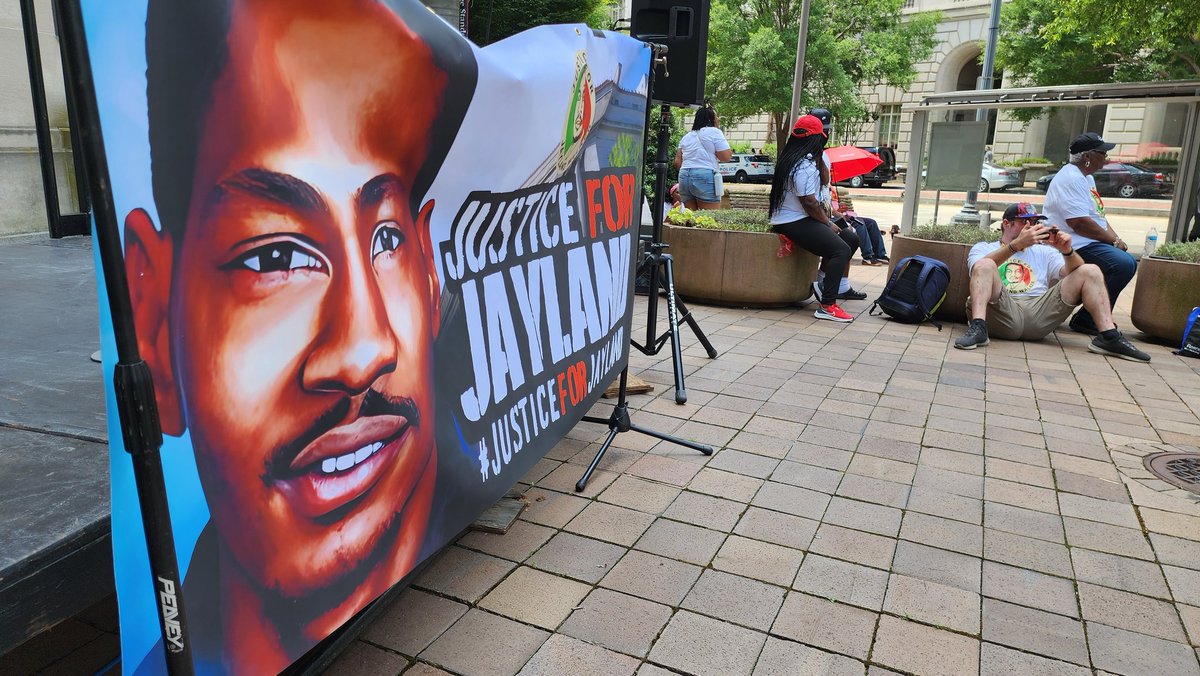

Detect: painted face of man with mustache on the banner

[127,2,448,635]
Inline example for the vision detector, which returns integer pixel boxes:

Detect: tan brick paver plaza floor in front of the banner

[334,267,1200,676]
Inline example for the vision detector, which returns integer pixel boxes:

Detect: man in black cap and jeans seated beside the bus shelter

[1045,131,1138,335]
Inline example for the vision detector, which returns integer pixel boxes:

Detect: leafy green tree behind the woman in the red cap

[706,0,941,153]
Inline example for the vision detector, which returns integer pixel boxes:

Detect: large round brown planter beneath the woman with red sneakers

[662,225,820,307]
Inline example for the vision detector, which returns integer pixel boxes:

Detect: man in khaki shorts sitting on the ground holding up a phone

[954,202,1150,361]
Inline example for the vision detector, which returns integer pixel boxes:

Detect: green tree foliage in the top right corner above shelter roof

[996,0,1200,86]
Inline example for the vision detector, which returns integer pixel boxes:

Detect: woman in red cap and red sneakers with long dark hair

[770,115,859,322]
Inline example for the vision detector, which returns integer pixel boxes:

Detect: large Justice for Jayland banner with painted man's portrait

[83,0,649,674]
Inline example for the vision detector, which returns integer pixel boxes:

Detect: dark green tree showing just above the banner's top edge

[467,0,618,46]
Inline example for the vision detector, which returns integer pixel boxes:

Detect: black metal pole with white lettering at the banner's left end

[54,0,194,675]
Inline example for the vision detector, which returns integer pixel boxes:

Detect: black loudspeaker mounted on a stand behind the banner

[630,0,710,106]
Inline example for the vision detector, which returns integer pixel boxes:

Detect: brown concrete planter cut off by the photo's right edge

[1129,257,1200,346]
